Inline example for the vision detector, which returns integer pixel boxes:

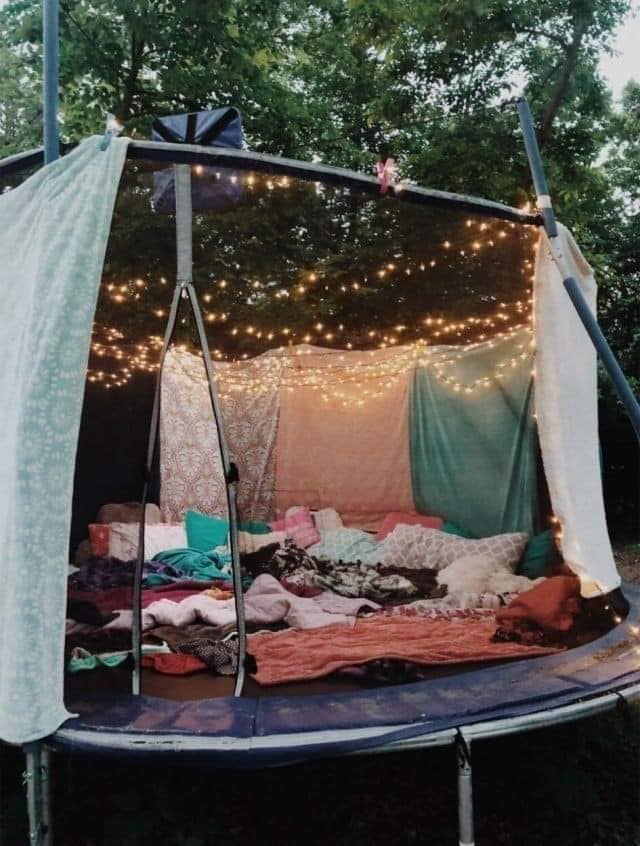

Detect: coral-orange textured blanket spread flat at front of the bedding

[249,616,558,685]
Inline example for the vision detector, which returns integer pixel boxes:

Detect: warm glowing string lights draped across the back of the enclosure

[88,202,533,403]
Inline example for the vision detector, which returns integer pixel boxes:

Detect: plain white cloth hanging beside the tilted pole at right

[534,226,620,597]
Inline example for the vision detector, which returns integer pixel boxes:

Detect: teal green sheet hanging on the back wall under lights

[409,331,538,536]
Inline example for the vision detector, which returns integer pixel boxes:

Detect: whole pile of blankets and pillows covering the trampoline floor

[67,506,558,685]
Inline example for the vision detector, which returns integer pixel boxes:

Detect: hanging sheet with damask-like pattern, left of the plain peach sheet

[160,348,278,522]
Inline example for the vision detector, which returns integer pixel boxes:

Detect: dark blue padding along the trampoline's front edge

[51,586,640,767]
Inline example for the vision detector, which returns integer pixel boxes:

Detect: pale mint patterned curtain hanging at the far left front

[0,137,128,743]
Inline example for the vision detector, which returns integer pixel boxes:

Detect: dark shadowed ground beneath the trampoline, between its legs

[0,545,640,846]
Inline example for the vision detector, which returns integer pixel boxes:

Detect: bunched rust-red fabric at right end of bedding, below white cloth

[496,576,581,632]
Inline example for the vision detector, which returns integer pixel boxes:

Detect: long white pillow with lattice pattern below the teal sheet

[380,525,529,573]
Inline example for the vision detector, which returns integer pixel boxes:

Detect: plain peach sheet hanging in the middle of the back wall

[276,347,413,528]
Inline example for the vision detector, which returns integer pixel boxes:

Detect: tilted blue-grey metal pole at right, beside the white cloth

[518,98,640,441]
